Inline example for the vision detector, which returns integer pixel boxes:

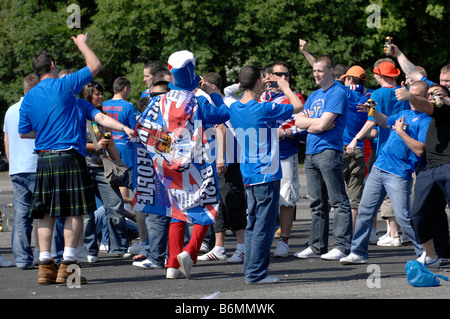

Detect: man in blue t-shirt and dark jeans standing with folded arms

[294,55,352,260]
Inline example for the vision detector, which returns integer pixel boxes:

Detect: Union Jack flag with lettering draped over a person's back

[132,90,219,225]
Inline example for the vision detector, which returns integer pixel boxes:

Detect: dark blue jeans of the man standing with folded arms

[305,149,352,254]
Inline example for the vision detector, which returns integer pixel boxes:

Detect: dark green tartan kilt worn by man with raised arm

[29,150,97,219]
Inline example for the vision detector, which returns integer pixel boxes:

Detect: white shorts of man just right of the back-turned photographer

[280,154,300,207]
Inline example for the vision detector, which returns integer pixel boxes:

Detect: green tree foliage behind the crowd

[0,0,449,154]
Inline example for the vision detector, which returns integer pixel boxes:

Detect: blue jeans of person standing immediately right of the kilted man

[84,167,128,256]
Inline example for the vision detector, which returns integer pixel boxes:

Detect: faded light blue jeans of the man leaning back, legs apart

[351,166,423,259]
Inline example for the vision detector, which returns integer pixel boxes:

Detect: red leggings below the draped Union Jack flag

[166,222,210,268]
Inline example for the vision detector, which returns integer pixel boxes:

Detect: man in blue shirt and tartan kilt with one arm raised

[19,34,133,284]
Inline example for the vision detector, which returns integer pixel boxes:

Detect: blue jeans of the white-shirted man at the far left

[11,173,36,268]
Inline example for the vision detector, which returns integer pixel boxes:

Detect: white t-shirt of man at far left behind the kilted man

[3,97,38,175]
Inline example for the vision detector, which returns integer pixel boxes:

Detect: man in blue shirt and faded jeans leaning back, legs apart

[340,81,431,265]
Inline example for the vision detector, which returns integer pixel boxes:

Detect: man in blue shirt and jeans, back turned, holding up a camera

[230,66,303,284]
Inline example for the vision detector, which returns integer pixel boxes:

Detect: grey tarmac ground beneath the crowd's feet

[0,172,450,308]
